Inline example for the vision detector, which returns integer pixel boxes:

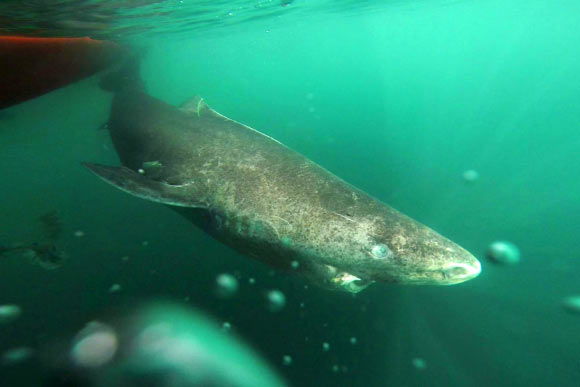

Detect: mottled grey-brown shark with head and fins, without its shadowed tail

[85,89,481,292]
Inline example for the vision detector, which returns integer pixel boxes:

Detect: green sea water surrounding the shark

[0,1,580,386]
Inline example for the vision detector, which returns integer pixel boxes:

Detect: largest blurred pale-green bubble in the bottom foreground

[63,303,286,387]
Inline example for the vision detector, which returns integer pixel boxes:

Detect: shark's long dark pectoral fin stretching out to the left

[83,163,207,208]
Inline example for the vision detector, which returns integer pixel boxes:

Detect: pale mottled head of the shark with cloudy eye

[322,208,481,291]
